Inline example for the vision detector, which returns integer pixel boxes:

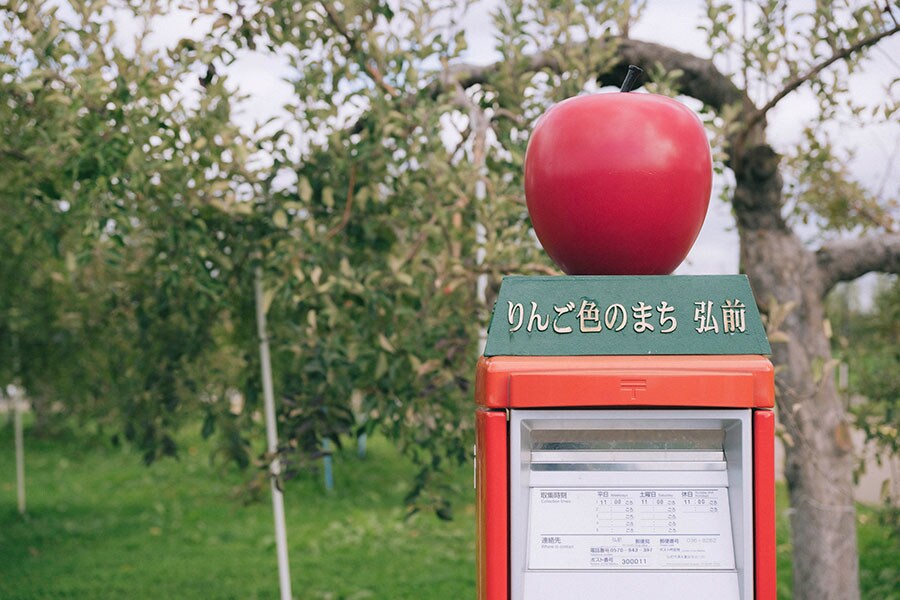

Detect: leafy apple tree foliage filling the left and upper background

[0,0,892,544]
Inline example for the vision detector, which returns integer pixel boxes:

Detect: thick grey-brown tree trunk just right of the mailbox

[734,144,859,600]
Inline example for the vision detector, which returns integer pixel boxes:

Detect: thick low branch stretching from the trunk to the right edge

[816,233,900,295]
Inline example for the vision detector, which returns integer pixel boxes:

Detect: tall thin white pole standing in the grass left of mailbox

[253,267,292,600]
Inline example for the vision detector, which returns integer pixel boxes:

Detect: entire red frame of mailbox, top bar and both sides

[475,355,776,600]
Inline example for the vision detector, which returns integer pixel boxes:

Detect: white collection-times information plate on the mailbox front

[528,487,734,570]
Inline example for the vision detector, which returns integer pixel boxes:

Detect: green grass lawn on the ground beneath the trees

[0,421,900,600]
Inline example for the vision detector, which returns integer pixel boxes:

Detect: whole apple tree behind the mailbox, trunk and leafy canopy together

[0,0,900,600]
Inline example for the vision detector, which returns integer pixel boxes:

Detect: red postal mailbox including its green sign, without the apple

[476,276,775,600]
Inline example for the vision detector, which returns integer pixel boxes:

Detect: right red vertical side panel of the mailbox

[753,410,776,600]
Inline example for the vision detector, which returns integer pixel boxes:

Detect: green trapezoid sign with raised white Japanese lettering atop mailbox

[484,275,771,356]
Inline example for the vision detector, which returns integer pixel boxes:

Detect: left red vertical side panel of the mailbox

[475,410,509,600]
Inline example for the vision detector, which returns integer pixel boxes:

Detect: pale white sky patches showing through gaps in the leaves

[137,0,900,274]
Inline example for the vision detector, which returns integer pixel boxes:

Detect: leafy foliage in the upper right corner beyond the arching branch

[702,0,898,231]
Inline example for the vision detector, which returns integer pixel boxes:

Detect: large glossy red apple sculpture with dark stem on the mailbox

[525,70,712,275]
